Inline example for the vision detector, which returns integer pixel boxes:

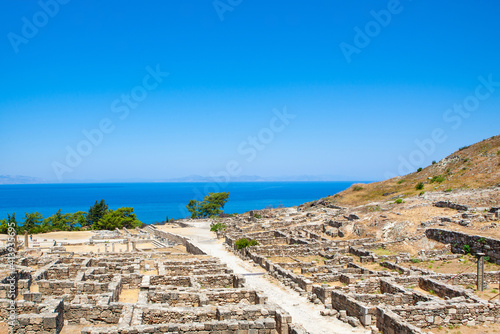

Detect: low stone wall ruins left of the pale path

[0,227,294,334]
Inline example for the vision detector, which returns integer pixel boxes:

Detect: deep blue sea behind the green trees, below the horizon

[0,182,355,224]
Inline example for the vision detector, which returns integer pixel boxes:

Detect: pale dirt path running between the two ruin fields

[172,223,371,334]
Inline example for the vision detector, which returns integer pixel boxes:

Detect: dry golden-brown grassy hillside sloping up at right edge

[325,136,500,205]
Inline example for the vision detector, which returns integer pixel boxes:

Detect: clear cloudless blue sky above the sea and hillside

[0,0,500,181]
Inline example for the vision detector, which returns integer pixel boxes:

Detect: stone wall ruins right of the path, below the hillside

[221,209,500,334]
